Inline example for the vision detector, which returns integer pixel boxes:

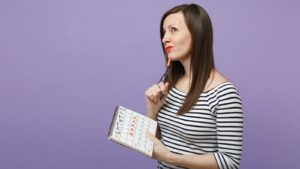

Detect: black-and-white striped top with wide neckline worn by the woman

[157,82,243,169]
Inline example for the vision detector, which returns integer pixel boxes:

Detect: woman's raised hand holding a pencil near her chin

[145,82,169,120]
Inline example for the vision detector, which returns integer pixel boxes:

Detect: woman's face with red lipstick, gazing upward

[162,12,192,61]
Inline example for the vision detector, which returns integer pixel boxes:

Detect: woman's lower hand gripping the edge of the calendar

[147,133,172,162]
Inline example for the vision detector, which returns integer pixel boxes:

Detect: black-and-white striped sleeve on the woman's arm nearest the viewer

[214,87,243,169]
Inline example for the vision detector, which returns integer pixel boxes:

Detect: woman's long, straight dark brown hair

[160,4,215,115]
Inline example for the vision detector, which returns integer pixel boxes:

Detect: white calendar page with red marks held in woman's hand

[108,106,157,157]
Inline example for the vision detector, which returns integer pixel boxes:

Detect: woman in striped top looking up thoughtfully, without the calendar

[145,4,243,169]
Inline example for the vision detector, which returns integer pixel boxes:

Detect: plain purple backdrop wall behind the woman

[0,0,300,169]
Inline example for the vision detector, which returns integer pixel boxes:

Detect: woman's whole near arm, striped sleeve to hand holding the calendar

[149,88,243,169]
